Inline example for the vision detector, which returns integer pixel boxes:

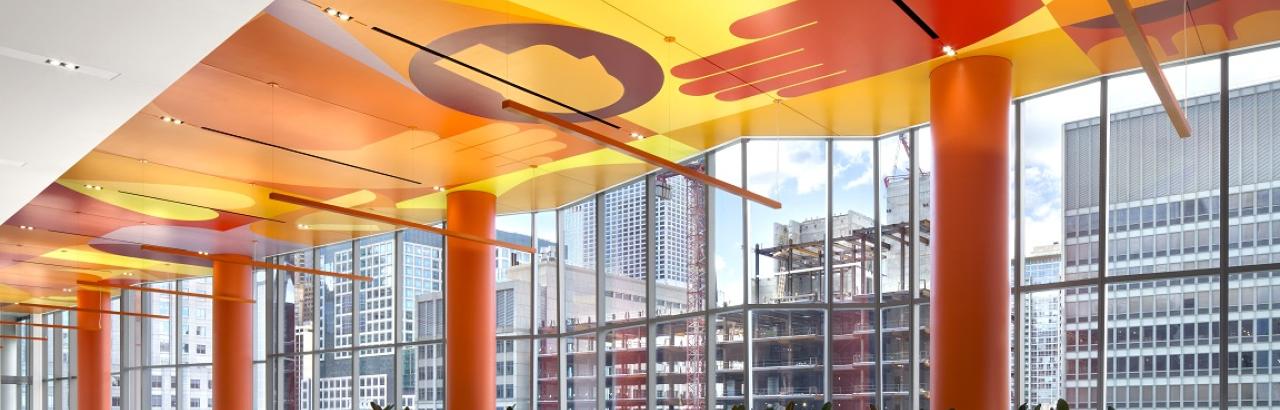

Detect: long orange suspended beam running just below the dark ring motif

[502,100,782,209]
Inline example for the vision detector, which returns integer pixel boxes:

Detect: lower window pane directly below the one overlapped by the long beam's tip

[751,310,826,409]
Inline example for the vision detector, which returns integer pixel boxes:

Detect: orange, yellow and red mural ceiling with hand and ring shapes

[0,0,1280,302]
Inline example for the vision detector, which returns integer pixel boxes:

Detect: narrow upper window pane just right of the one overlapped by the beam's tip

[831,141,878,304]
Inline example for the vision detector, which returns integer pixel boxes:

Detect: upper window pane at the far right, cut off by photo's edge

[1226,49,1280,267]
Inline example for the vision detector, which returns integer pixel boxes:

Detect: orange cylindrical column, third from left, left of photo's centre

[444,191,498,410]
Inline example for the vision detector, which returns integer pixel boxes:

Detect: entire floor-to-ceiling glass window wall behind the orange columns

[22,41,1280,410]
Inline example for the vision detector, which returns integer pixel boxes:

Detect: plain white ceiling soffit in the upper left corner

[0,0,272,220]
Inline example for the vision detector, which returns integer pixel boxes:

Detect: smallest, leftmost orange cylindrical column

[76,288,111,410]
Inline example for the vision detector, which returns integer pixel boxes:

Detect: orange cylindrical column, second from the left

[211,255,253,409]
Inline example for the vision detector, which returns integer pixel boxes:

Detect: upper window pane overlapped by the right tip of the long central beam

[746,140,828,304]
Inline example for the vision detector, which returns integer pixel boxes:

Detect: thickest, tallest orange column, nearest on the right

[929,56,1012,410]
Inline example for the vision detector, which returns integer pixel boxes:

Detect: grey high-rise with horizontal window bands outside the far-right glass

[1061,83,1280,409]
